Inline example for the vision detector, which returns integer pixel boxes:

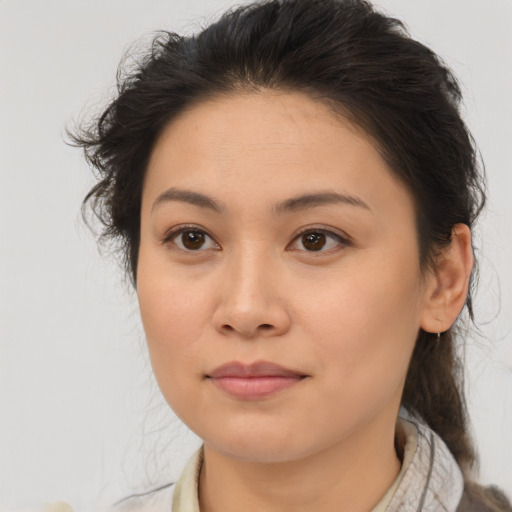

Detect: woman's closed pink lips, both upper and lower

[208,361,306,400]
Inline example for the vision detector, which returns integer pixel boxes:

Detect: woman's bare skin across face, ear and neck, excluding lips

[137,91,472,512]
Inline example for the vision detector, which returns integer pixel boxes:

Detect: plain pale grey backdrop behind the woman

[0,0,512,512]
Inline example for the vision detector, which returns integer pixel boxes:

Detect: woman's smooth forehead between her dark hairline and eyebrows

[144,92,410,218]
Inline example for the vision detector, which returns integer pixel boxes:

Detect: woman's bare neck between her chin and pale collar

[199,414,400,512]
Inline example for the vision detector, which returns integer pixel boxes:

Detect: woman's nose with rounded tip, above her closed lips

[212,250,290,339]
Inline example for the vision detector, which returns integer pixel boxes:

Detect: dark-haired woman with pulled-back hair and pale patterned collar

[72,0,512,512]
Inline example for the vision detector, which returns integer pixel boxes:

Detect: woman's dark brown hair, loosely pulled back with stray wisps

[73,0,511,510]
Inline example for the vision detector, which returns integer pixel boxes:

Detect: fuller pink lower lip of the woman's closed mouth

[210,375,303,400]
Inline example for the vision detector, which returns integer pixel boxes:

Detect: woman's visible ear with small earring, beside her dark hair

[421,224,474,332]
